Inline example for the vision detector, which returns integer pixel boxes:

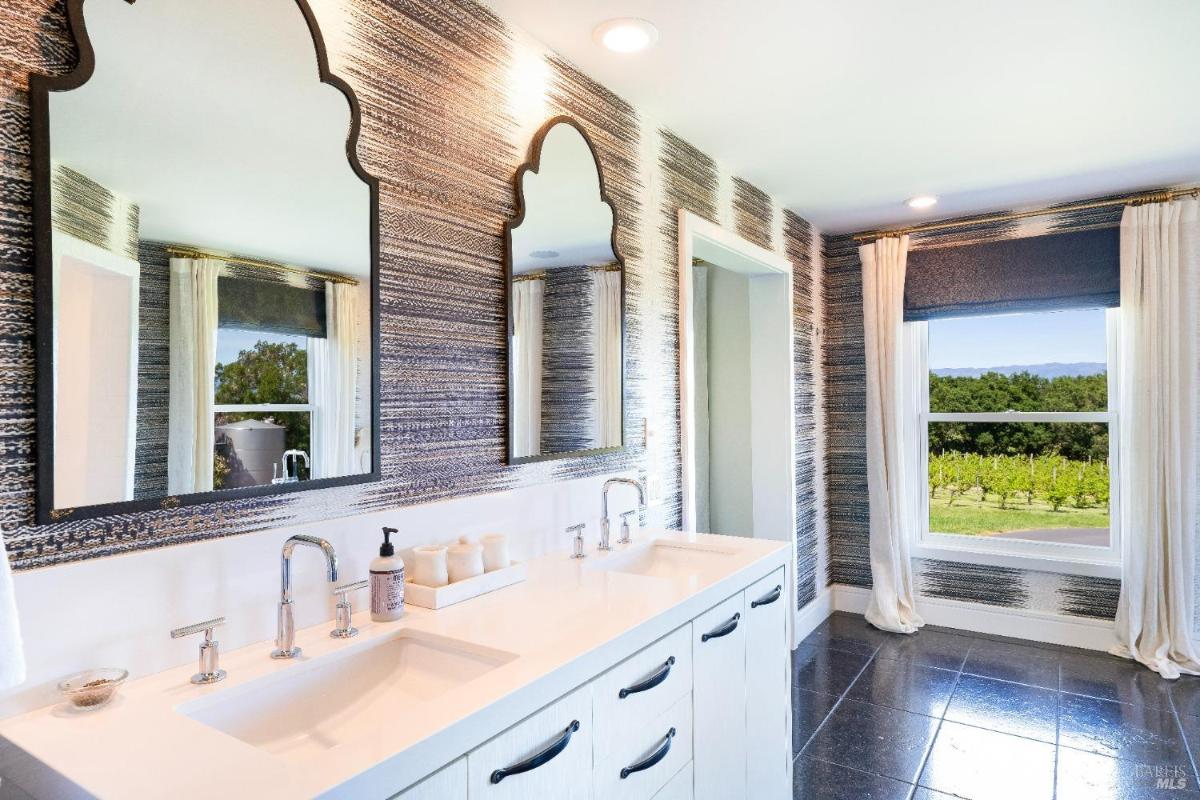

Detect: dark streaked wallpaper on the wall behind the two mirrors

[0,0,821,599]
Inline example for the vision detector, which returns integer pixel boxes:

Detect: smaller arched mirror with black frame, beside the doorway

[506,118,625,464]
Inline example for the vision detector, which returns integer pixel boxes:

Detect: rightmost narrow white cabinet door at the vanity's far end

[743,569,792,800]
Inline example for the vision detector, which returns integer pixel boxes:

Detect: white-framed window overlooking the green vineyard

[908,308,1120,575]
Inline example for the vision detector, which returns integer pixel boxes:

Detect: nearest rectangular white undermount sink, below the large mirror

[180,631,517,762]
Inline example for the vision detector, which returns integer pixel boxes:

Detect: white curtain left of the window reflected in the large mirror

[167,258,220,494]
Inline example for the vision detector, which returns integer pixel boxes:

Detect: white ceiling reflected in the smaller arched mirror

[512,124,614,273]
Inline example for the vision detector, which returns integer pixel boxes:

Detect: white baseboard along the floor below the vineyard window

[825,585,1116,650]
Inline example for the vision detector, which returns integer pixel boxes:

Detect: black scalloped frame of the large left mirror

[29,0,380,524]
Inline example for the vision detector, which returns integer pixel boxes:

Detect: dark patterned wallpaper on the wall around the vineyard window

[822,199,1122,619]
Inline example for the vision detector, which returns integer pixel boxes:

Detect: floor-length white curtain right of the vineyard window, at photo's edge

[1114,199,1200,678]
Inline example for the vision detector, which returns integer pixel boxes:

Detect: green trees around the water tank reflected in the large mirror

[212,342,312,489]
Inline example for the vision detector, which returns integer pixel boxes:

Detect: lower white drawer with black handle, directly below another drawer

[594,693,692,800]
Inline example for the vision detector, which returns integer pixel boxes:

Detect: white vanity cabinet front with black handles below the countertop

[395,569,791,800]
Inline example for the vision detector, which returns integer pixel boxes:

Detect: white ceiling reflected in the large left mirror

[50,0,371,277]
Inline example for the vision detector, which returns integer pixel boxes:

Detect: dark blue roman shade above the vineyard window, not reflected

[904,228,1121,321]
